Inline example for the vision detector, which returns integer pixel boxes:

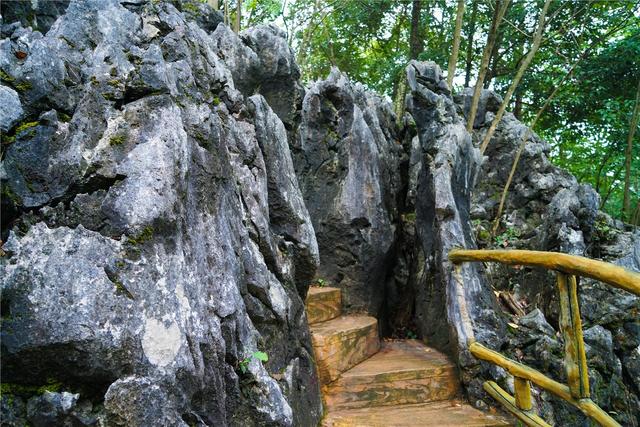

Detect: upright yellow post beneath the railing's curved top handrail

[558,273,589,399]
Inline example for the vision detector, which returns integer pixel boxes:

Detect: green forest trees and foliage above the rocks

[208,0,640,224]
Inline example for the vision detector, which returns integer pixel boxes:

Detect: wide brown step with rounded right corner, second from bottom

[323,340,458,411]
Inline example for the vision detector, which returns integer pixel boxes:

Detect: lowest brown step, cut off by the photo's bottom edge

[322,401,513,427]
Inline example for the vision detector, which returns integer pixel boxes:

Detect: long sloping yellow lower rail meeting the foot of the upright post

[469,342,621,427]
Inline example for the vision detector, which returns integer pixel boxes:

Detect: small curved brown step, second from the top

[310,316,380,384]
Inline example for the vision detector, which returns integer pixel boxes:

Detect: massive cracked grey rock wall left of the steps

[0,0,322,426]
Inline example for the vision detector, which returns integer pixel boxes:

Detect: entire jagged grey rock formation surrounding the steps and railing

[0,0,640,427]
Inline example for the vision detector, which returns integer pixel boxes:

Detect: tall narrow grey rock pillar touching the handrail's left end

[407,61,504,402]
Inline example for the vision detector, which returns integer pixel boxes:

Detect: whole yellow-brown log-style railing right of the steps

[449,249,640,427]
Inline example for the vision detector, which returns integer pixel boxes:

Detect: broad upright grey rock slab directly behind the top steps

[293,69,403,316]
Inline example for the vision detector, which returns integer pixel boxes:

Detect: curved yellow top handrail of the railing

[449,249,640,295]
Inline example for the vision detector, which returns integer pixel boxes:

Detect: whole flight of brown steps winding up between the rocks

[306,287,511,427]
